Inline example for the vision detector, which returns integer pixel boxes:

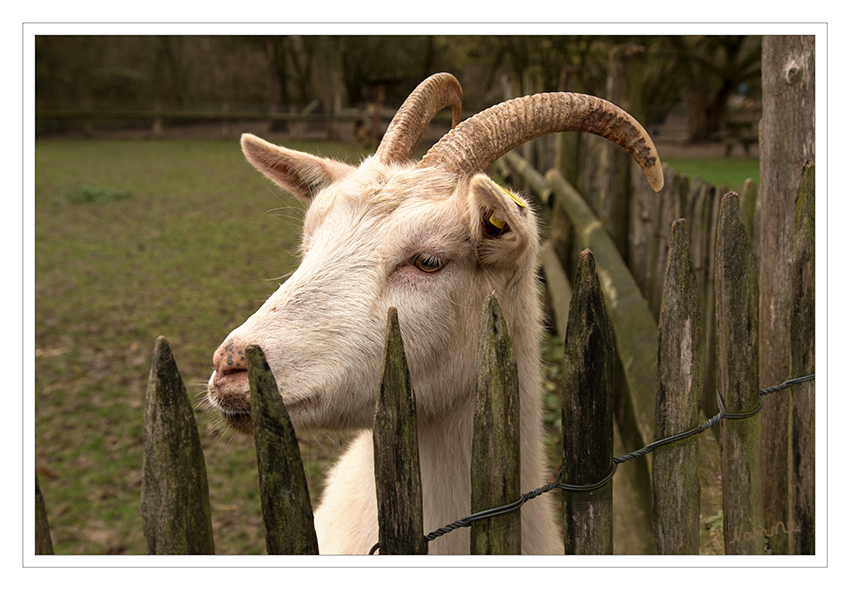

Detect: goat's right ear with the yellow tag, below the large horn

[469,174,537,265]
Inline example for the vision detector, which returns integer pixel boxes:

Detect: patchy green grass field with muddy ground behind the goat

[34,140,758,555]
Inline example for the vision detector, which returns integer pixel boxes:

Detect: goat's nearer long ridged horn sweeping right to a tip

[418,92,664,192]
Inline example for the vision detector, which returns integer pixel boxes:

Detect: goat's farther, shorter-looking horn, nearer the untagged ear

[376,73,463,164]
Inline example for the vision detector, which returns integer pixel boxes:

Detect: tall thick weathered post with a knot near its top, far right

[759,35,815,554]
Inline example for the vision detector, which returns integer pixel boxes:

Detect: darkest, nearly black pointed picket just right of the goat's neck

[561,250,614,555]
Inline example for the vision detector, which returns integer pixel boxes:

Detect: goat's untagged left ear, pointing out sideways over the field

[242,133,352,203]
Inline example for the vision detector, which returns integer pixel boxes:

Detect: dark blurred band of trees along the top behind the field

[36,35,761,141]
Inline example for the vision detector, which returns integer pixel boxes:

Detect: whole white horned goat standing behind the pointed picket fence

[208,73,663,554]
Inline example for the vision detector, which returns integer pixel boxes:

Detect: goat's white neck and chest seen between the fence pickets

[316,272,548,554]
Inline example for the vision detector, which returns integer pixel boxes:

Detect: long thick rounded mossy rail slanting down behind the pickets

[546,170,658,472]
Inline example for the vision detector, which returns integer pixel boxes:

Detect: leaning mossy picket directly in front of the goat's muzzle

[245,345,319,555]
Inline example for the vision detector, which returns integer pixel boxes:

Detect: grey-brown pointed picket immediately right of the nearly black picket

[652,219,705,555]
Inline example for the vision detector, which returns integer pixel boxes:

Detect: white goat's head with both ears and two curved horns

[208,74,663,442]
